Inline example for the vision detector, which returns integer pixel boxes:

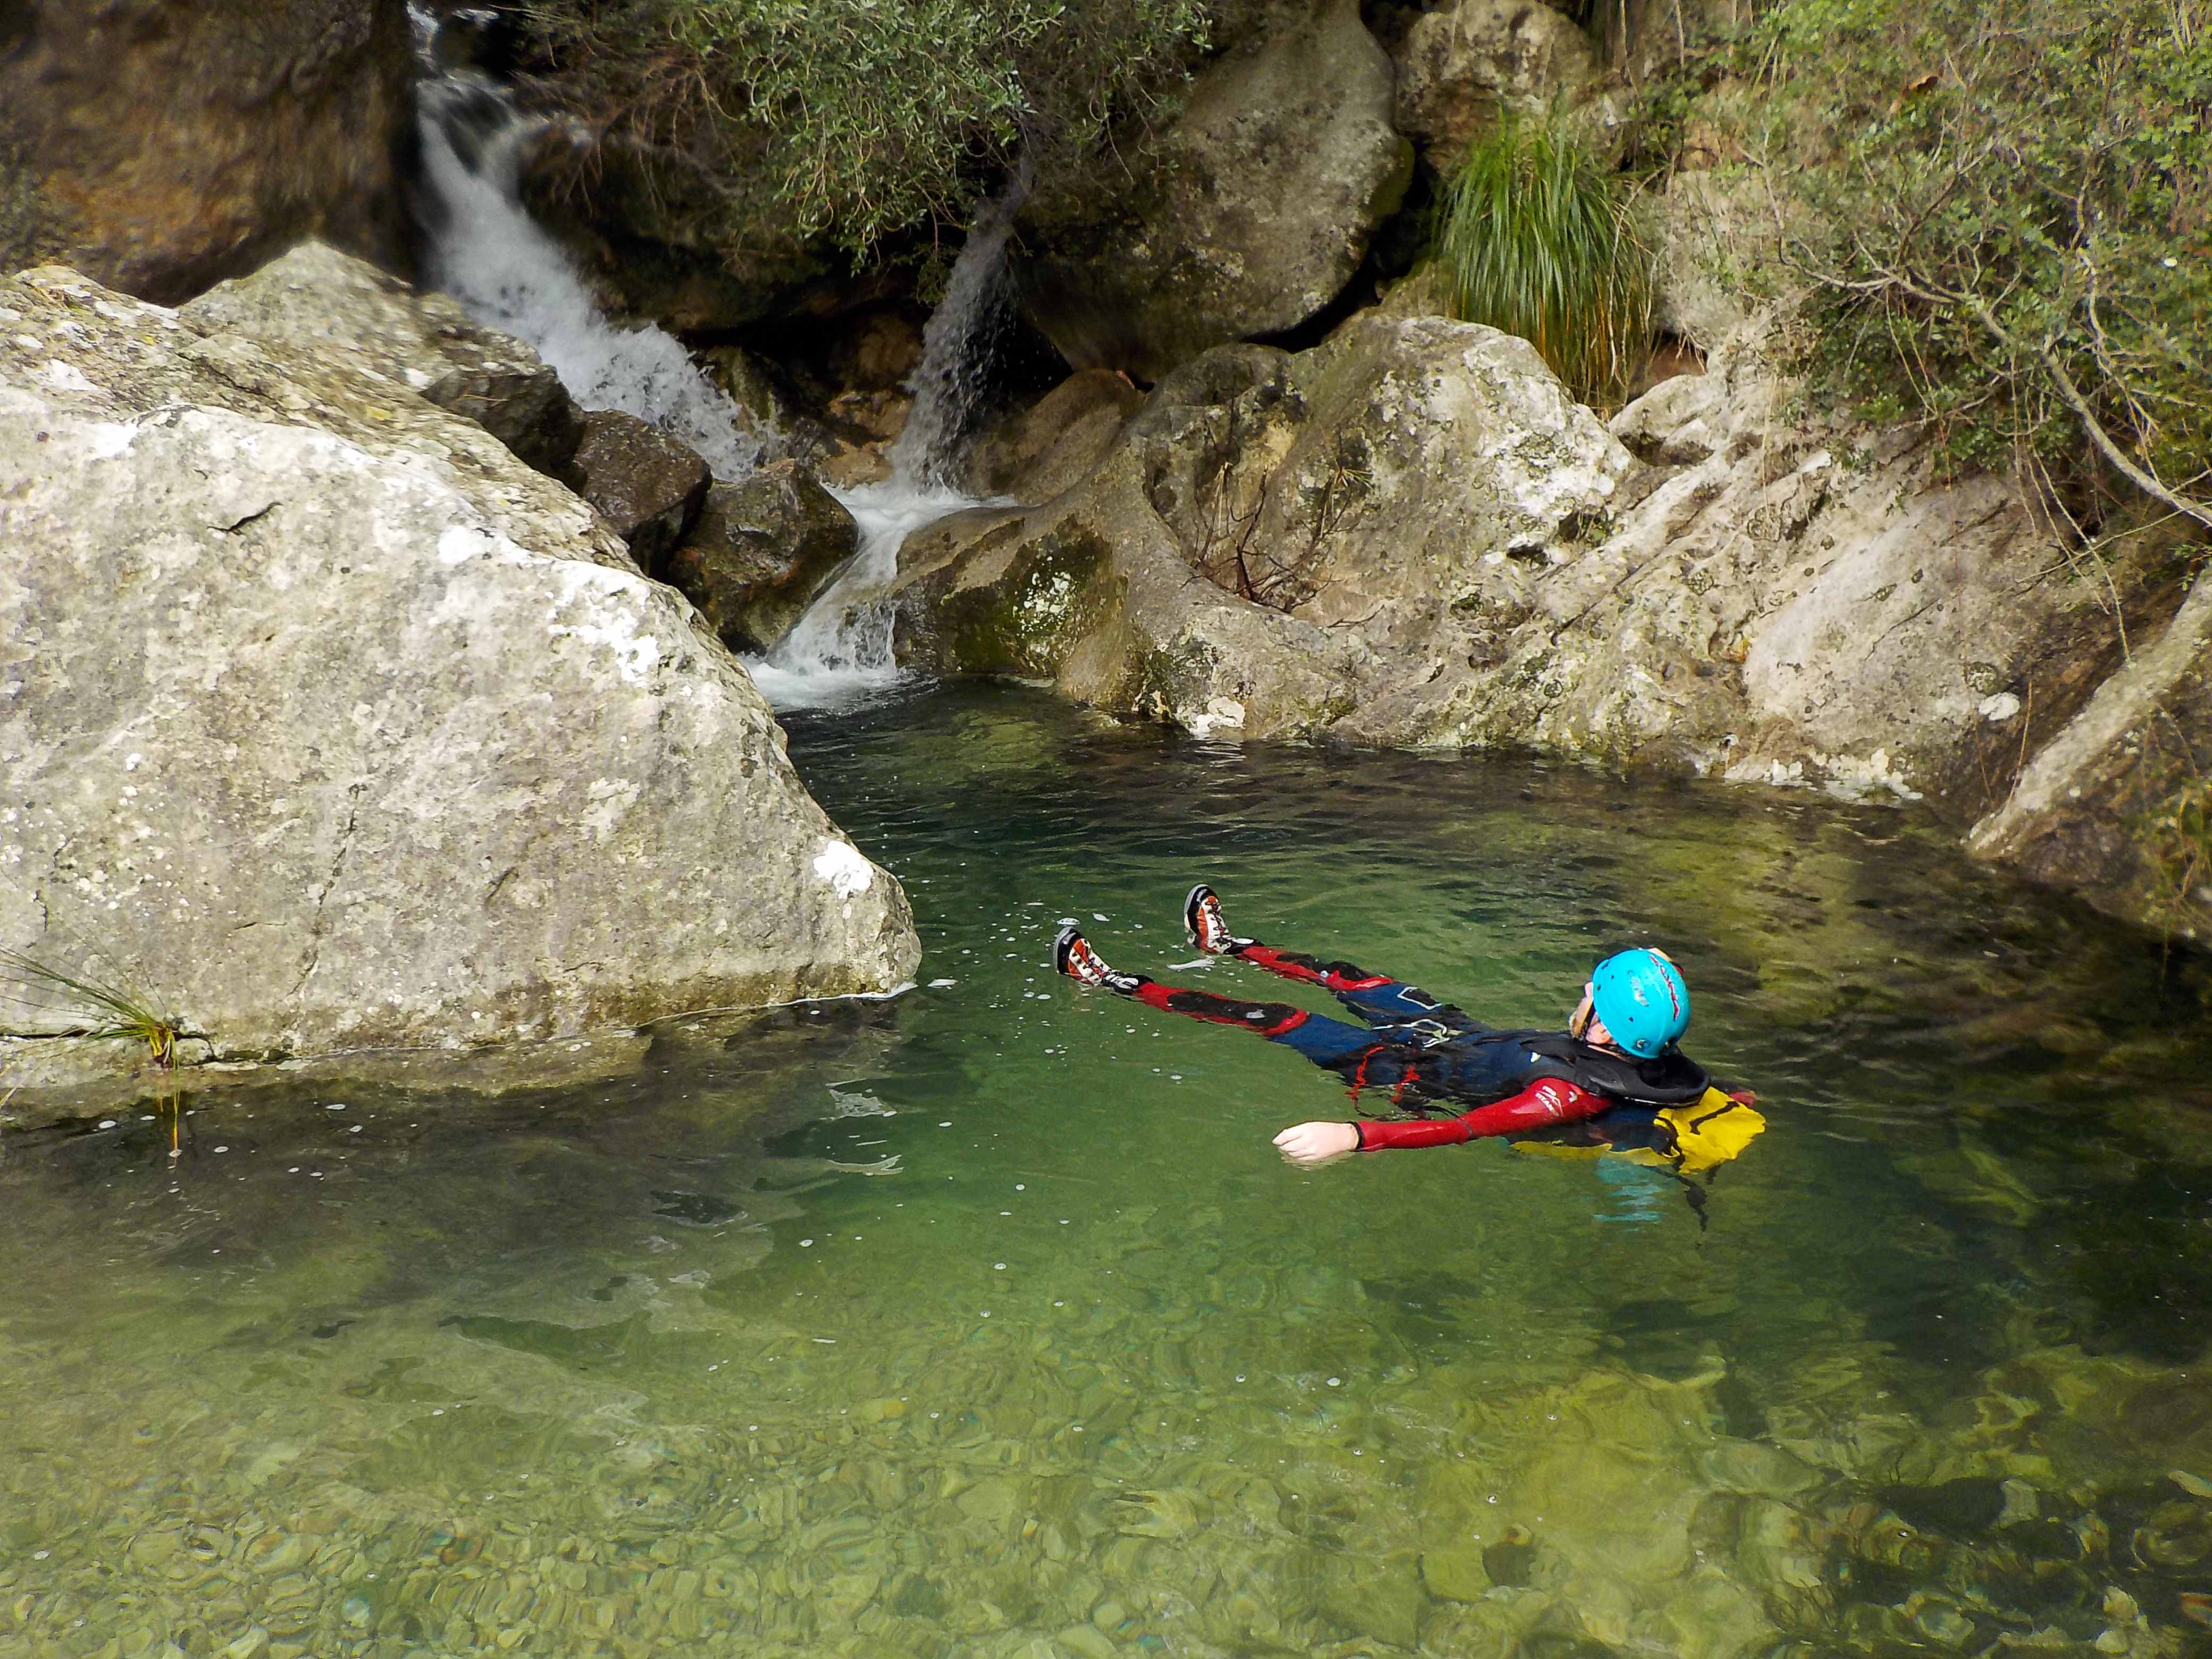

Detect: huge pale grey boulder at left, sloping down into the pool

[0,270,918,1079]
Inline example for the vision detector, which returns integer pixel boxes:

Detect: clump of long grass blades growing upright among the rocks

[1436,117,1653,403]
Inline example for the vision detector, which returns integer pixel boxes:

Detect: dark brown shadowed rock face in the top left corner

[0,0,414,303]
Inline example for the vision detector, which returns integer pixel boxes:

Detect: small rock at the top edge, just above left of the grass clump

[1392,0,1597,172]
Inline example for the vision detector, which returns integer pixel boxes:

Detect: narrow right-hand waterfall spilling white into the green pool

[748,162,1028,708]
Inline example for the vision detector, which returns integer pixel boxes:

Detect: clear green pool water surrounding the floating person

[0,690,2212,1659]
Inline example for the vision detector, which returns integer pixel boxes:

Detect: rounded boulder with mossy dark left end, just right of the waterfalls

[900,312,1630,741]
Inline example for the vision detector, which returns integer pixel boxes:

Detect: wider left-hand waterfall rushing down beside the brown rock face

[416,21,765,480]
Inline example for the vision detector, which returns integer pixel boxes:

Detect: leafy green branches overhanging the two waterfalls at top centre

[517,0,1208,254]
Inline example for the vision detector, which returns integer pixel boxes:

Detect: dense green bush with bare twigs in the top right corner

[1737,0,2212,529]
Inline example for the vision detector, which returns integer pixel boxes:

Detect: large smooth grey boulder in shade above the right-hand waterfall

[1022,0,1411,381]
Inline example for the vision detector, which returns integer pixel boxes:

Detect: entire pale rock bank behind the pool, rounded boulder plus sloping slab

[900,309,2113,816]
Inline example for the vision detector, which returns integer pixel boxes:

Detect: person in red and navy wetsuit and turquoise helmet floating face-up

[1053,883,1756,1163]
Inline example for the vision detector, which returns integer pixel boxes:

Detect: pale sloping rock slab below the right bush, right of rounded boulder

[1371,332,2108,812]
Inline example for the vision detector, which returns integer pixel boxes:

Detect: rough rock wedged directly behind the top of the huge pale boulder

[177,241,584,478]
